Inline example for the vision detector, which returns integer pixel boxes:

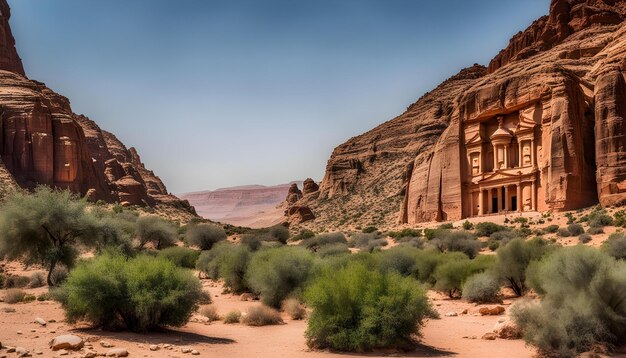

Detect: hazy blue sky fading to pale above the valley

[9,0,550,193]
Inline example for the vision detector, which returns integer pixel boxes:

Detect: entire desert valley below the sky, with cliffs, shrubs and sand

[0,0,626,358]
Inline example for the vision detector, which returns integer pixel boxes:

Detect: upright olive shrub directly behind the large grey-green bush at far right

[496,239,552,296]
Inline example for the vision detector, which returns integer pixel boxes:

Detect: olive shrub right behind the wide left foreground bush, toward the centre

[196,242,252,293]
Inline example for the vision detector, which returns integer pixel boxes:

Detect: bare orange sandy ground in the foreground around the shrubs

[0,270,534,358]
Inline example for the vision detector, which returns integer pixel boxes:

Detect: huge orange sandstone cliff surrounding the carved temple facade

[301,0,626,226]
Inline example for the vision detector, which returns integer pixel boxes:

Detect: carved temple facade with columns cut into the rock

[461,107,544,217]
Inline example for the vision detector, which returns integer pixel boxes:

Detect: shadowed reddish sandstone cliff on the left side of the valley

[0,0,195,218]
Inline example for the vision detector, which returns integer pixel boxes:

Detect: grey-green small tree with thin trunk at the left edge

[0,186,99,286]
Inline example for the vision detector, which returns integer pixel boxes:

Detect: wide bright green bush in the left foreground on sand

[61,254,203,331]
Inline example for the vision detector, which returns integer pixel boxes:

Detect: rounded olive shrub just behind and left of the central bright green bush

[246,247,313,308]
